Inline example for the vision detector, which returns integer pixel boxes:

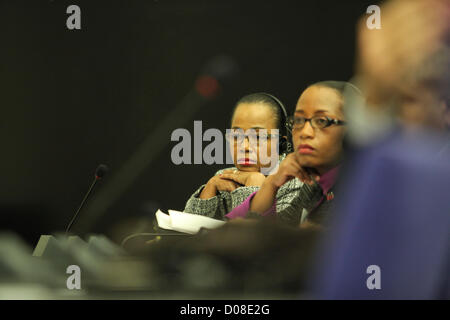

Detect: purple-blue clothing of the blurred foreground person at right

[317,132,450,299]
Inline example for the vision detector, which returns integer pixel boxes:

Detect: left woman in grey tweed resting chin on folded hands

[184,93,292,219]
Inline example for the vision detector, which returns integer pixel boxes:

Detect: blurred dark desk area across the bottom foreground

[0,224,315,299]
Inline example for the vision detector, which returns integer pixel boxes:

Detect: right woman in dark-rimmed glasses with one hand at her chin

[225,81,360,226]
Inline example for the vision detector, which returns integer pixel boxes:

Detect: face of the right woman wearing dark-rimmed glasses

[292,86,346,174]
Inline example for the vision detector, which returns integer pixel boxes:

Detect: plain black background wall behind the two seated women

[0,0,377,243]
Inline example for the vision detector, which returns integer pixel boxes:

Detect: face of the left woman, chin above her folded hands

[231,103,278,172]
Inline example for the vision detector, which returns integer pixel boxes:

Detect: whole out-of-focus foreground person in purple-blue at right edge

[314,0,450,299]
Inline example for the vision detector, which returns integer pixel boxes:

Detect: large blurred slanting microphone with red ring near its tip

[75,56,238,232]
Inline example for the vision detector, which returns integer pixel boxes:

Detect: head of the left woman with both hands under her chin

[228,93,283,172]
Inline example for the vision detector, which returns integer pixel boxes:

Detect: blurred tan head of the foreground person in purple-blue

[356,0,450,134]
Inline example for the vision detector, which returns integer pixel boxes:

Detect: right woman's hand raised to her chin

[267,153,319,189]
